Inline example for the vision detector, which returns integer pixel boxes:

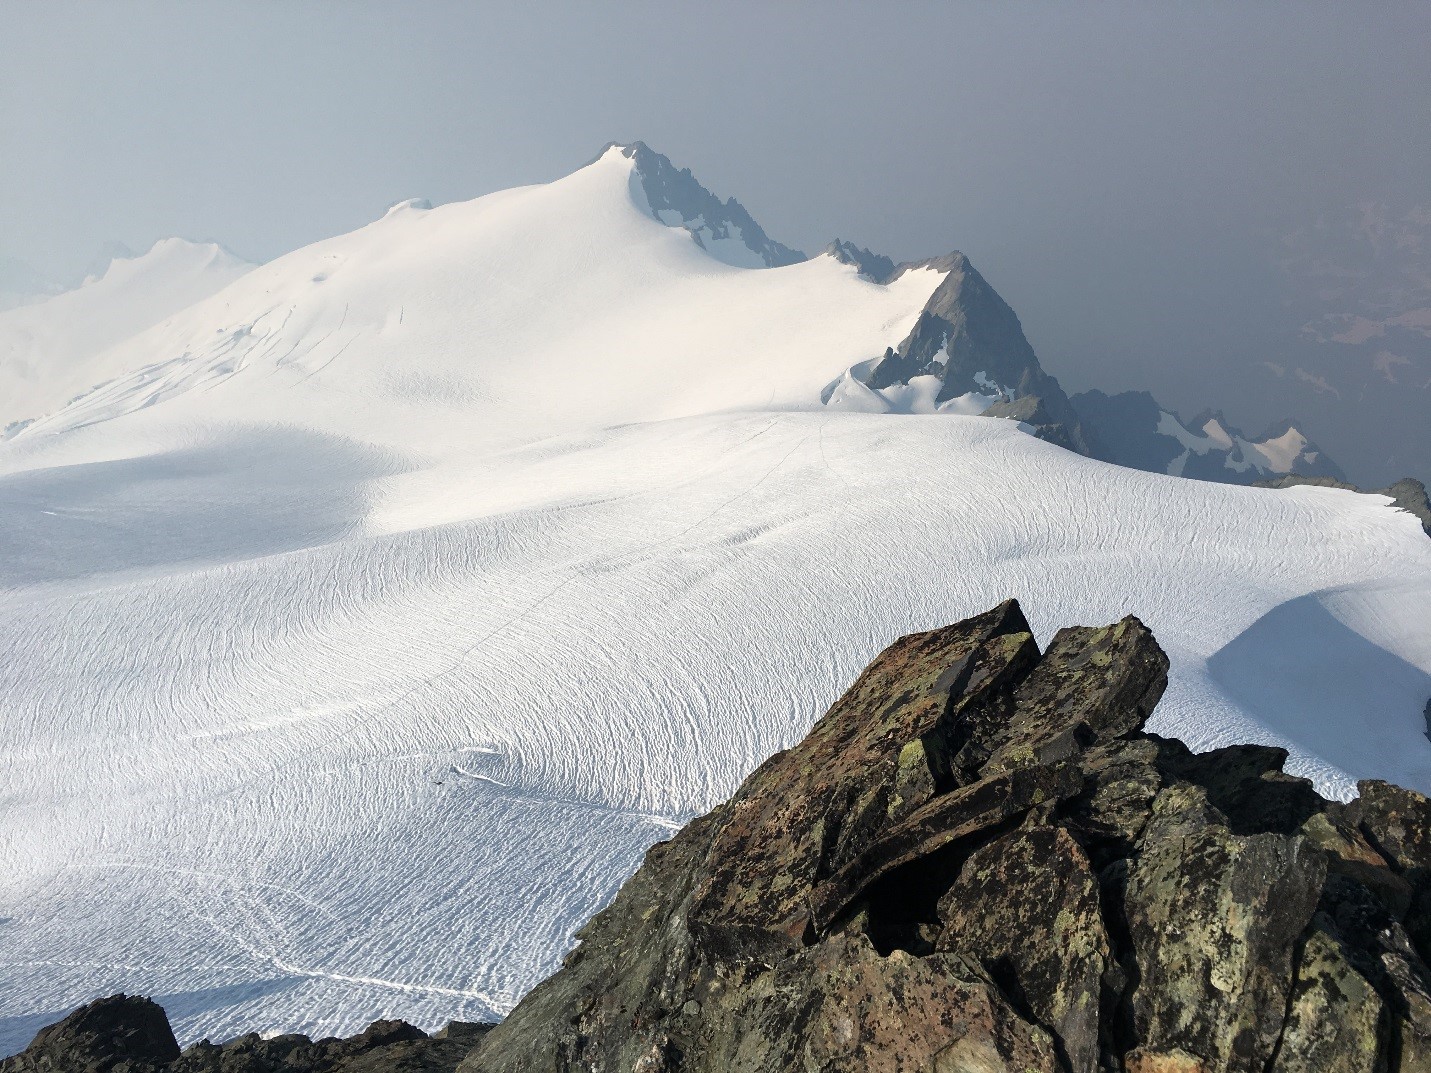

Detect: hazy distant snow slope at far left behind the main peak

[0,239,252,435]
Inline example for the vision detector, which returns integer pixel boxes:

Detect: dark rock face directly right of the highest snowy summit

[607,142,806,268]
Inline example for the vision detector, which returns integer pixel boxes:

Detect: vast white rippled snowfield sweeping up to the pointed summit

[0,150,1431,1053]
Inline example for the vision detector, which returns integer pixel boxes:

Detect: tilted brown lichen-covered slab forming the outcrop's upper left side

[690,601,1037,953]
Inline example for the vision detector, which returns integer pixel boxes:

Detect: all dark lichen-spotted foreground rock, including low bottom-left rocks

[8,601,1431,1073]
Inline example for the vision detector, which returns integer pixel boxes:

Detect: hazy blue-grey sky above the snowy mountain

[0,0,1431,437]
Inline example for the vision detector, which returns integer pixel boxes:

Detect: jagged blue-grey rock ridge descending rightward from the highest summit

[608,142,1345,484]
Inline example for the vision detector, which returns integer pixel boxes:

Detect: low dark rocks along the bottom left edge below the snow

[0,994,492,1073]
